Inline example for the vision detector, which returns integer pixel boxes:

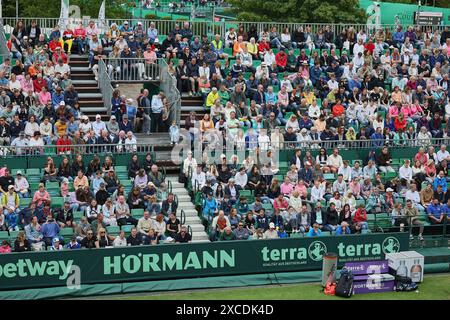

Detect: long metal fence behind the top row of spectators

[3,17,444,37]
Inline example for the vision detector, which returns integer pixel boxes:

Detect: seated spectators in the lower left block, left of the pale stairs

[0,154,191,252]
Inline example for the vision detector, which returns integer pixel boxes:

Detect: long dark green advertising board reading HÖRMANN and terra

[0,233,409,290]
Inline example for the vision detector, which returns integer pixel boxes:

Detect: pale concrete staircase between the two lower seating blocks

[167,175,209,243]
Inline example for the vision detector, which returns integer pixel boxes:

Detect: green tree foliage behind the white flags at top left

[3,0,130,18]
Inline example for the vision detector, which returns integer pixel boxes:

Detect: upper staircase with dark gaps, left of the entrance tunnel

[69,54,109,121]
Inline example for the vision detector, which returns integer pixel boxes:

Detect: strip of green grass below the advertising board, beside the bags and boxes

[120,274,450,300]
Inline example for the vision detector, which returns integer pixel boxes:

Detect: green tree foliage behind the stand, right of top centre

[228,0,366,23]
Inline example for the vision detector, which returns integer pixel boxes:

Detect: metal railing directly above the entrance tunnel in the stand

[104,58,164,82]
